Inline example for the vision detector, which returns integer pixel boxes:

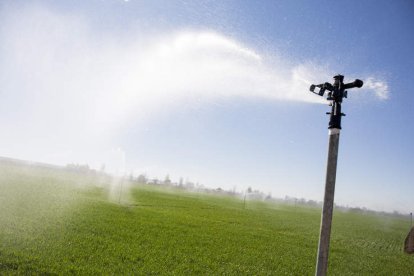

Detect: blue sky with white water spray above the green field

[0,0,414,213]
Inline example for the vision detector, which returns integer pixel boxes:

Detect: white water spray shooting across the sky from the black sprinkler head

[0,7,388,167]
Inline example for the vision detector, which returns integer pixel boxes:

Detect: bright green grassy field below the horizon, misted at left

[0,162,414,275]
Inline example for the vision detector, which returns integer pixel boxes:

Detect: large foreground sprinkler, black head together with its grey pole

[309,75,364,276]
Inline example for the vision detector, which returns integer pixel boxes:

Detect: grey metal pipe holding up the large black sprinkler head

[315,128,340,276]
